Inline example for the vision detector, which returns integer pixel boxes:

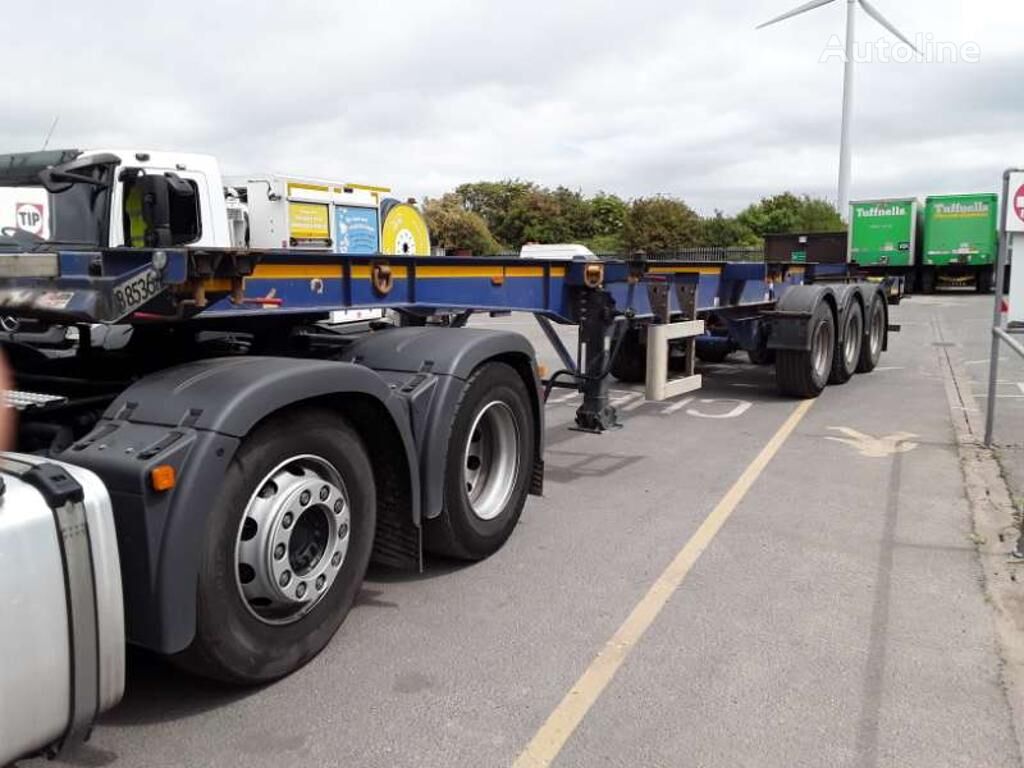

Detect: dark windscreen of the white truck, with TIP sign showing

[0,155,114,250]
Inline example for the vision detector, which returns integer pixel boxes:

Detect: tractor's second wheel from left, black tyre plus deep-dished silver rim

[423,360,536,560]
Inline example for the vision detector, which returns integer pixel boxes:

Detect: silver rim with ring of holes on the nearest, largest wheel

[234,454,351,625]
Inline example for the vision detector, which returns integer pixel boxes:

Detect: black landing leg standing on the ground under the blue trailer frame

[569,290,625,433]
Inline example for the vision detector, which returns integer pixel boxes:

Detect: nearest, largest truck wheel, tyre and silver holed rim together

[174,410,376,684]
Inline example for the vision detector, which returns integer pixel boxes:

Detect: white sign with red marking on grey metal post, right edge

[985,168,1024,445]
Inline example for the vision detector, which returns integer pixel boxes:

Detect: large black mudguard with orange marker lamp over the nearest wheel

[57,356,420,653]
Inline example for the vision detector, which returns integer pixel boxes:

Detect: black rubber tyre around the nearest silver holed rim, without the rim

[172,409,377,685]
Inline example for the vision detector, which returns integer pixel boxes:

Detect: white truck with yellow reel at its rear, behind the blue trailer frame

[0,148,430,256]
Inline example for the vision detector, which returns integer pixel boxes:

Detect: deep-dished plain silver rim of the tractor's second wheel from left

[462,400,519,520]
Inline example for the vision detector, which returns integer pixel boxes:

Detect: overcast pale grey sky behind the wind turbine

[0,0,1024,213]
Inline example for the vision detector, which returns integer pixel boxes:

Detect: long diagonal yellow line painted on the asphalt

[513,400,814,768]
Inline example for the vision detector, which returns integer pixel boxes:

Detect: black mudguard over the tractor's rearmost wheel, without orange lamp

[343,326,544,517]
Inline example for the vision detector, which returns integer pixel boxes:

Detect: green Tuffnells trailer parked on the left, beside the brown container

[847,198,921,292]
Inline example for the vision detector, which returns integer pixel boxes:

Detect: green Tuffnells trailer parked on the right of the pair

[919,194,998,293]
